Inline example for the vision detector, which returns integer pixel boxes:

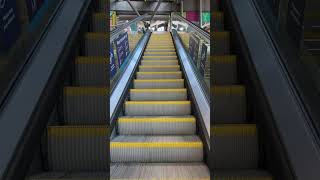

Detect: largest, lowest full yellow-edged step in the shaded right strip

[211,124,259,169]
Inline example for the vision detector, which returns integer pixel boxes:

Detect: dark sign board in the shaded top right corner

[287,0,305,48]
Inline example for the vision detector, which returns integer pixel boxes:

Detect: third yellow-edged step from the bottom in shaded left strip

[75,56,108,87]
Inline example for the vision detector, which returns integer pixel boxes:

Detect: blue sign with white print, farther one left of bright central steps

[115,33,130,68]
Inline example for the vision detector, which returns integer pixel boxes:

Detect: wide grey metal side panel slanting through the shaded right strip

[228,0,320,180]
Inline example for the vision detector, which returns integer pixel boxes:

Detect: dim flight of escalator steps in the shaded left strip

[27,1,109,180]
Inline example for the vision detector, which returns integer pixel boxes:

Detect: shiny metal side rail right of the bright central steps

[172,30,210,148]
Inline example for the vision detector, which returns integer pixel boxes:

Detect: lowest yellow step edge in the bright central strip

[110,141,203,148]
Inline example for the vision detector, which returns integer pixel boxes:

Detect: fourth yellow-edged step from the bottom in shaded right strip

[213,31,230,55]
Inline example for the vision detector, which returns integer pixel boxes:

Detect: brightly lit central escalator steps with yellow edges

[110,32,210,179]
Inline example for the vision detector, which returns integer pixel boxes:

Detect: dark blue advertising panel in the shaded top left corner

[0,0,20,52]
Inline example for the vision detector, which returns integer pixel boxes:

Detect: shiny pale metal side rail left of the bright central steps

[109,30,151,130]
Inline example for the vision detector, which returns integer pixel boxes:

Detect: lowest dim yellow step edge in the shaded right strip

[210,124,257,136]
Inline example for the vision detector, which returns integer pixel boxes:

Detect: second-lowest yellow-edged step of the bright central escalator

[118,116,196,135]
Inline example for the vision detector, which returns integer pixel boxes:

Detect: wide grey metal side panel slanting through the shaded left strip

[0,0,91,179]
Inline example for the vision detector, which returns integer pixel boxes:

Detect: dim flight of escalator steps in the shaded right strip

[211,8,273,180]
